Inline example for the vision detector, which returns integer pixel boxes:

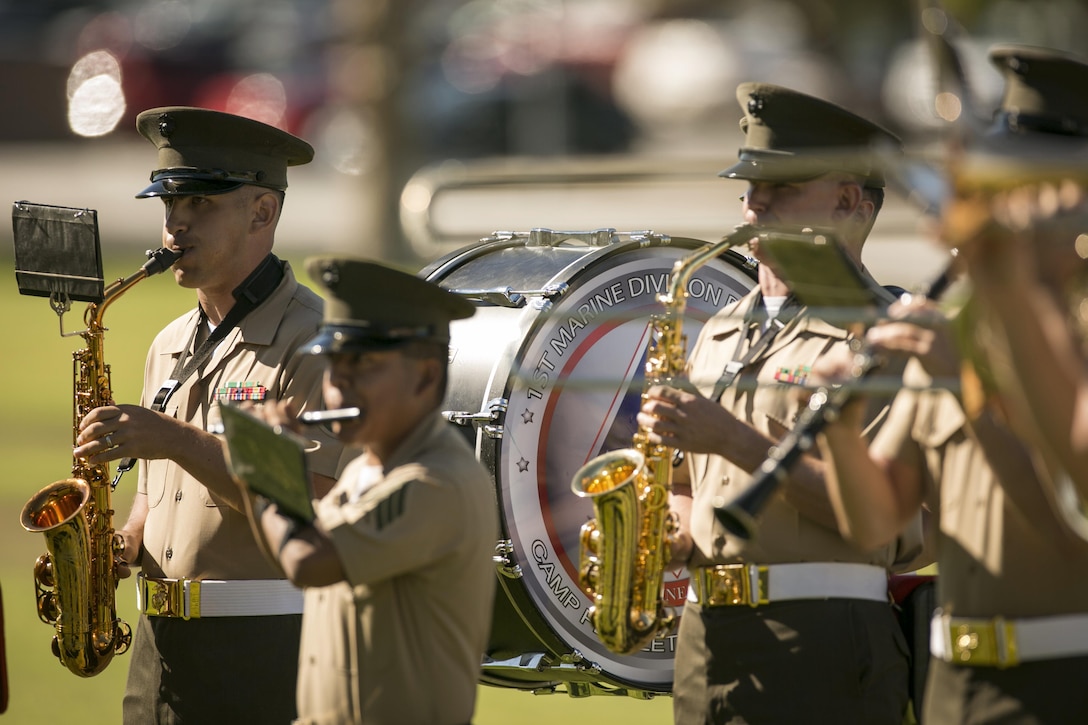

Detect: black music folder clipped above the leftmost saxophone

[11,201,104,304]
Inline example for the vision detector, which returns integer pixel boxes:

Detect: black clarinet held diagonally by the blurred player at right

[714,265,953,540]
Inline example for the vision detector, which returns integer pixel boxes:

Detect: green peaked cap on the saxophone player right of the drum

[718,83,902,188]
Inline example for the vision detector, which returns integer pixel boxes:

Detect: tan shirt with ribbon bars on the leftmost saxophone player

[139,266,347,579]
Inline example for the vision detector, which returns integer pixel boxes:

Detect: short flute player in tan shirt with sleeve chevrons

[244,257,498,725]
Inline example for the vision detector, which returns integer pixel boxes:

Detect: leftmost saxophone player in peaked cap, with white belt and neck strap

[76,107,347,725]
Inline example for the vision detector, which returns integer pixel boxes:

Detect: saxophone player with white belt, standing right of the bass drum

[639,84,920,724]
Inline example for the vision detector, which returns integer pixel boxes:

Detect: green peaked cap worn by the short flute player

[304,256,475,355]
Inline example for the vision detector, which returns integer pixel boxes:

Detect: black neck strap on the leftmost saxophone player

[112,254,284,488]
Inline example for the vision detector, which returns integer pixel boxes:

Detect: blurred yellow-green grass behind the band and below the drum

[0,250,671,725]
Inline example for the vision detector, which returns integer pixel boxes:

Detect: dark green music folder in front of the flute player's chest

[220,405,313,524]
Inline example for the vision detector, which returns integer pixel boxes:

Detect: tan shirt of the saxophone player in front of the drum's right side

[689,288,920,567]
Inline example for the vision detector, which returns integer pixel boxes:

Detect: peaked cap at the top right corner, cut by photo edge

[990,45,1088,137]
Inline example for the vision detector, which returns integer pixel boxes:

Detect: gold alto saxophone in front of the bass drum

[570,224,757,654]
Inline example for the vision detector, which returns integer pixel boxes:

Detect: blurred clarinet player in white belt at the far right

[818,46,1088,725]
